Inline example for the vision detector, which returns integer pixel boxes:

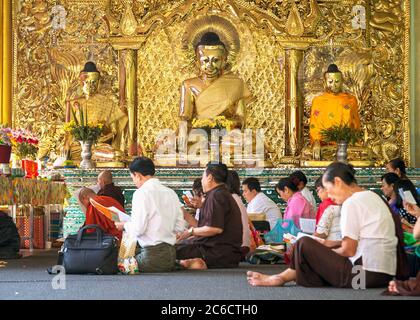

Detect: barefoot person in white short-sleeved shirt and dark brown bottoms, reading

[247,162,406,288]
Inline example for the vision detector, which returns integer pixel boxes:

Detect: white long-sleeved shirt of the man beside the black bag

[124,178,185,248]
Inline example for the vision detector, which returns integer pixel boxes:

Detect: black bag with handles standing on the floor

[62,225,118,274]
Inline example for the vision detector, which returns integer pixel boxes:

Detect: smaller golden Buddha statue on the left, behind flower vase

[66,61,128,166]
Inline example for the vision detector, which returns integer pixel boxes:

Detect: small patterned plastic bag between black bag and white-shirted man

[118,232,139,274]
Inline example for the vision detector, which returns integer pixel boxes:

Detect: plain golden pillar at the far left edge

[0,0,12,126]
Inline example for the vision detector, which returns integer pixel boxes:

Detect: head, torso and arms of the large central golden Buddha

[178,32,253,155]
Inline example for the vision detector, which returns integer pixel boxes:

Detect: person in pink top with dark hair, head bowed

[276,177,315,228]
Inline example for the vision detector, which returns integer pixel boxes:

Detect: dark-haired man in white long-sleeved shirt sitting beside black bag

[115,157,185,273]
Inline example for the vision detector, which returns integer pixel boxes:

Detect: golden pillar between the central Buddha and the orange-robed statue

[284,48,303,157]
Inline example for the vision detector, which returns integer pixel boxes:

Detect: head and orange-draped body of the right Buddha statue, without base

[309,64,360,144]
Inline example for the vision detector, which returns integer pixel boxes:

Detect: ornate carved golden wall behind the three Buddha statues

[13,0,410,165]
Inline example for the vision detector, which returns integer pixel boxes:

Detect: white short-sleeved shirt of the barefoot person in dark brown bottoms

[341,191,398,275]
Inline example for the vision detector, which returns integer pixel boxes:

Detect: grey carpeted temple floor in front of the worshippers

[0,249,420,300]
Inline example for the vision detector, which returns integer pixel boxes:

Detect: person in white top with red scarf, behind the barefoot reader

[313,176,341,240]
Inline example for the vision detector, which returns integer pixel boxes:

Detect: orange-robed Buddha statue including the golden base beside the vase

[303,64,370,160]
